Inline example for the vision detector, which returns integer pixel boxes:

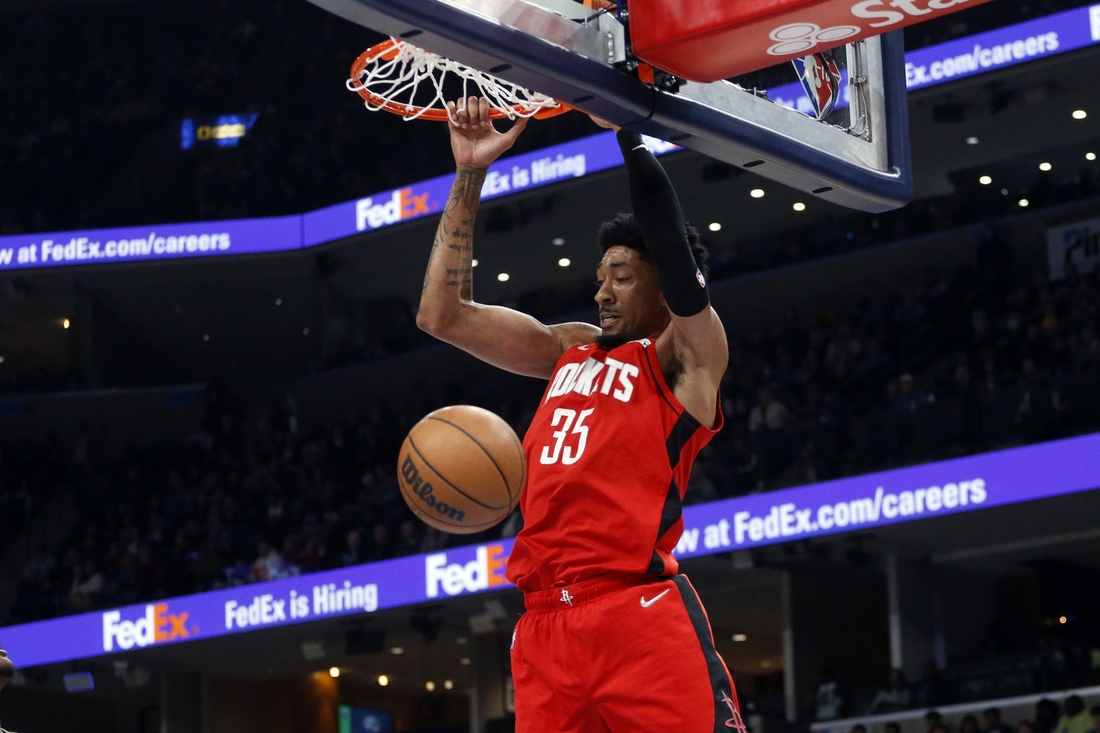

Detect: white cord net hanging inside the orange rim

[348,39,561,122]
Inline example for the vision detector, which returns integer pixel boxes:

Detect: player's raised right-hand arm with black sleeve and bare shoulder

[616,125,729,427]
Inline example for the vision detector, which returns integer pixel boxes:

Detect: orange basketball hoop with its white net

[348,39,572,122]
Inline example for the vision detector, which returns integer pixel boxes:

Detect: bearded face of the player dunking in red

[596,247,670,343]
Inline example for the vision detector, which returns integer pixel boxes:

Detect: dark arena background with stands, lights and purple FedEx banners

[0,0,1100,733]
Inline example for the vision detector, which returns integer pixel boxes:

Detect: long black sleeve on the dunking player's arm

[617,130,711,317]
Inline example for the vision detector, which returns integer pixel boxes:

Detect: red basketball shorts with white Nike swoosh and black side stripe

[512,575,746,733]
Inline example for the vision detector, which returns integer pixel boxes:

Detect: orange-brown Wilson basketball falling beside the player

[397,405,527,535]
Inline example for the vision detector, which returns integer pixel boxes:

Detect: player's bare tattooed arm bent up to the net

[416,97,600,379]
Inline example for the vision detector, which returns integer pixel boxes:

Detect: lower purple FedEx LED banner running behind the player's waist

[3,434,1100,667]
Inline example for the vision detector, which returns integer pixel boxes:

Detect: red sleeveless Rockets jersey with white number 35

[507,339,722,592]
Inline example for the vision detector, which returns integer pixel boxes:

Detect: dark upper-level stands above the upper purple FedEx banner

[0,0,1088,234]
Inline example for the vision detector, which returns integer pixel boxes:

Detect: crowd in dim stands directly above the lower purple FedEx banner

[3,217,1100,619]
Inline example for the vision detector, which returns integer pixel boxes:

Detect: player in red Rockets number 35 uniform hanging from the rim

[417,98,745,733]
